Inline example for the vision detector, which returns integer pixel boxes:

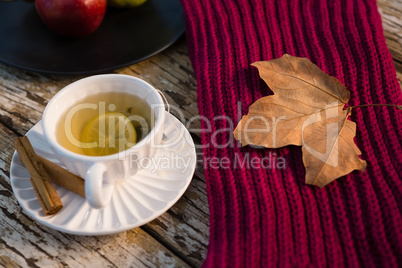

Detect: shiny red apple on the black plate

[35,0,107,37]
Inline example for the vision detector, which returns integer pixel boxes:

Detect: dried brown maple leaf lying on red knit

[234,54,367,187]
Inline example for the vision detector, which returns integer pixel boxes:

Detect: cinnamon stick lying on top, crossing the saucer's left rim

[14,137,63,215]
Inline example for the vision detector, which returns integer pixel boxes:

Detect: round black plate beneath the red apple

[0,0,185,74]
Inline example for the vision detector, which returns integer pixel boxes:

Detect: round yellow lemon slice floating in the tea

[81,112,137,156]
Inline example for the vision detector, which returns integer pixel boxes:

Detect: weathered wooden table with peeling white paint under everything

[0,0,402,267]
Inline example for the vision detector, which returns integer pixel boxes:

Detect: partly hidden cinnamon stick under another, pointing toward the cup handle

[38,155,85,197]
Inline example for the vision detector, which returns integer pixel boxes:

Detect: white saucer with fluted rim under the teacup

[10,114,197,235]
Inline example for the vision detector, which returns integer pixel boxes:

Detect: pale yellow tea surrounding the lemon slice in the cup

[56,92,155,155]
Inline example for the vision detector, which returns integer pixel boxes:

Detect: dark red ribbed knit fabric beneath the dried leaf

[182,0,402,267]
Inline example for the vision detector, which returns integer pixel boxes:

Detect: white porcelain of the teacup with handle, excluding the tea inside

[42,74,165,208]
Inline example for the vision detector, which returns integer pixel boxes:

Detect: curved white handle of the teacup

[85,163,114,208]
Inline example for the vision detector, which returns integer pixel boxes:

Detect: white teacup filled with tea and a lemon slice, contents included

[42,74,165,208]
